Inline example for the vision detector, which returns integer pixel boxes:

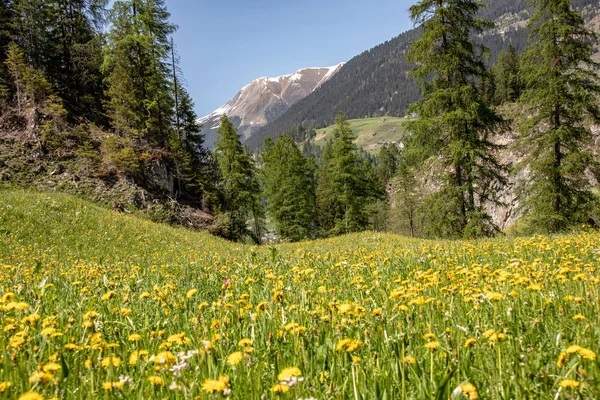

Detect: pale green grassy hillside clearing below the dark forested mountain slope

[315,117,407,153]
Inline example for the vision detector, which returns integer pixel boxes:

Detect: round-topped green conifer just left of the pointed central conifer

[262,135,316,241]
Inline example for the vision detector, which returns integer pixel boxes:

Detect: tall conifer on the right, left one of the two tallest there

[408,0,504,237]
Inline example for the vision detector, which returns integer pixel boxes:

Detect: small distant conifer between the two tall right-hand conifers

[493,45,523,104]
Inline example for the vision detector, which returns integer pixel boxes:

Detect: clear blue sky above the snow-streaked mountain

[166,0,414,116]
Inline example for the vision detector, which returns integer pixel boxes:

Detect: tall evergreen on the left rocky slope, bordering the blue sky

[103,0,176,146]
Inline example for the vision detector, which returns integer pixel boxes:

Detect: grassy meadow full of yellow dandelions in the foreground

[0,191,600,399]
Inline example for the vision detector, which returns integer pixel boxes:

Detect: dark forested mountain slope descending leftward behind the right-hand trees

[246,0,600,149]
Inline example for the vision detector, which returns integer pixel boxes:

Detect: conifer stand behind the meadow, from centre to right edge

[221,0,600,240]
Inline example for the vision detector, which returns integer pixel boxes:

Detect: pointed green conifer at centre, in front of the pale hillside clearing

[317,113,384,236]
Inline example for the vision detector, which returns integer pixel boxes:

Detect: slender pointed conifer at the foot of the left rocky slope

[215,115,264,242]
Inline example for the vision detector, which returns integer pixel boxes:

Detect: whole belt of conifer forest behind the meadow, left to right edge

[0,0,600,243]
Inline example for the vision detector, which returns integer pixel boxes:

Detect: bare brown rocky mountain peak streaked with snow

[199,63,344,149]
